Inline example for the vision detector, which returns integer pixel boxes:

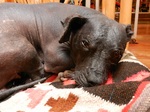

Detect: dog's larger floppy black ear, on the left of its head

[59,14,87,43]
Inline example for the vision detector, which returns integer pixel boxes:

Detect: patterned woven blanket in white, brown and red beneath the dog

[0,51,150,112]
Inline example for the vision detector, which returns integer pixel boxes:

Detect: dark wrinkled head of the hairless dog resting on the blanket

[59,15,133,86]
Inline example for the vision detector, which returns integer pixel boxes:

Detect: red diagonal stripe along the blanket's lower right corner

[122,81,150,112]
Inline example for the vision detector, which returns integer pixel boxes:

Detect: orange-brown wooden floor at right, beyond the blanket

[128,24,150,68]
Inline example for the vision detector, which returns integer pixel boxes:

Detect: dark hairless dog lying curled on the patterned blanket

[0,3,133,88]
